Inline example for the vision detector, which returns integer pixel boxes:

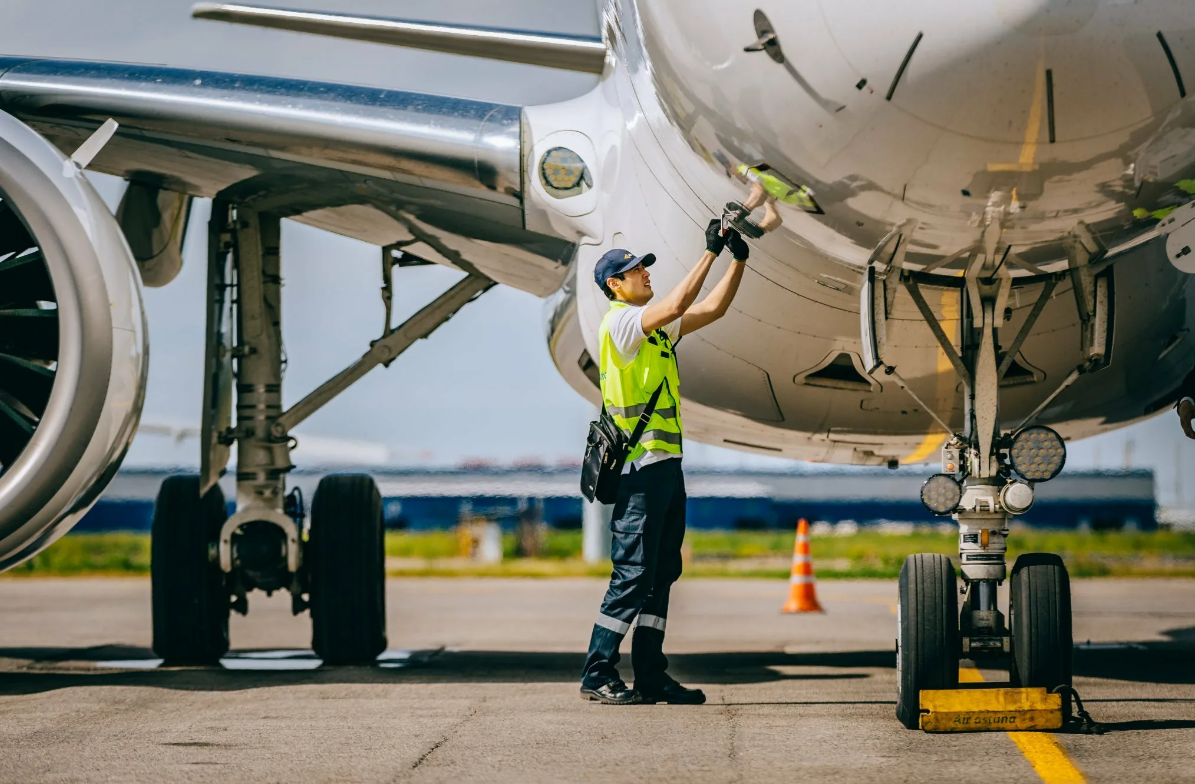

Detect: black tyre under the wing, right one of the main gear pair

[305,473,386,664]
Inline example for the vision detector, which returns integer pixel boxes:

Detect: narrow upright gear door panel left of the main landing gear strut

[200,200,233,496]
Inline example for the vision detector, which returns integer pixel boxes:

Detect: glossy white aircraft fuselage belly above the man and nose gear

[544,0,1195,463]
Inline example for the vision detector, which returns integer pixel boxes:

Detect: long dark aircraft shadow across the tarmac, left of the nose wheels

[0,645,894,694]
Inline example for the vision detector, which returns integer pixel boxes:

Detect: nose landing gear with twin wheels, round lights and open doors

[860,211,1114,729]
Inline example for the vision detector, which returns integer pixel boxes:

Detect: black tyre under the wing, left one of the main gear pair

[149,476,229,664]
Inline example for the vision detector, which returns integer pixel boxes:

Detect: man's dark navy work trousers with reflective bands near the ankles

[581,458,686,688]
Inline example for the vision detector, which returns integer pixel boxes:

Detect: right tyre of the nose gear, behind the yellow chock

[1009,552,1073,703]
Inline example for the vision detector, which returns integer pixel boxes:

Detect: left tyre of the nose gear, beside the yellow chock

[896,553,960,729]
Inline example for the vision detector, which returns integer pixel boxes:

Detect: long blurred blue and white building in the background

[75,465,1157,531]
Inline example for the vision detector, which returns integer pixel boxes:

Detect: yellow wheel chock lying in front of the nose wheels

[921,686,1062,733]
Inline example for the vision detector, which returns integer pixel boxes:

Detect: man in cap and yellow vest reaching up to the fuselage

[581,219,748,705]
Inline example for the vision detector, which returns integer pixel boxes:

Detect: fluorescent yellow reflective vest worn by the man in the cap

[598,301,681,463]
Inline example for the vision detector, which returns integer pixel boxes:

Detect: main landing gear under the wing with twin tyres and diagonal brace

[152,198,494,664]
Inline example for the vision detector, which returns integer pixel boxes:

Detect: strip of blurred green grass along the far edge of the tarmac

[6,531,1195,580]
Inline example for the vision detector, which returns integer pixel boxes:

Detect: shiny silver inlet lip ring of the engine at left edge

[0,112,112,540]
